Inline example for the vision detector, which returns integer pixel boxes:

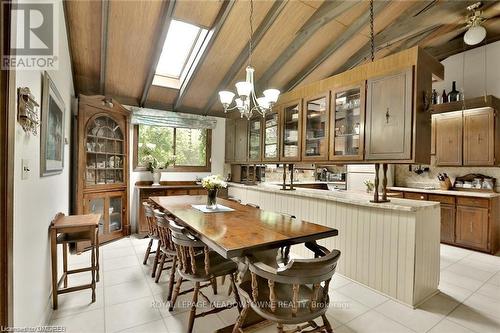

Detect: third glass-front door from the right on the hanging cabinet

[280,100,302,161]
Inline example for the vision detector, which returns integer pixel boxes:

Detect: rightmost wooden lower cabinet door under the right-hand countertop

[455,206,488,251]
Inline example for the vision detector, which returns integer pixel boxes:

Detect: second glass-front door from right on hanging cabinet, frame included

[302,93,330,161]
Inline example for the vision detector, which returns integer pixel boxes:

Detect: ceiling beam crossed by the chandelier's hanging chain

[203,0,288,114]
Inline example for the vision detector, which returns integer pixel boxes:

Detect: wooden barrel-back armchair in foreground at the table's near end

[233,243,340,333]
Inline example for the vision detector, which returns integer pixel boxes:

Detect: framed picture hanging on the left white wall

[40,72,65,177]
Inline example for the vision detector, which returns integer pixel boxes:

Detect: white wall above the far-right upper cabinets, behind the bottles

[432,42,500,98]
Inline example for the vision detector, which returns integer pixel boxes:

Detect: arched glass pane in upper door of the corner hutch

[85,116,124,185]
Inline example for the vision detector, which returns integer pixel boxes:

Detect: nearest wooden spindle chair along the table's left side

[169,220,241,333]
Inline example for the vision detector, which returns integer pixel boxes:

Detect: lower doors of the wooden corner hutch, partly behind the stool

[83,191,126,242]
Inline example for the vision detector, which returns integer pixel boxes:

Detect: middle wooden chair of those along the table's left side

[154,210,177,301]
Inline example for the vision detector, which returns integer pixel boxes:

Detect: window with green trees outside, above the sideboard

[134,125,211,171]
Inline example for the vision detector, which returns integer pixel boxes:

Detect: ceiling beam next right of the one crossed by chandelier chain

[256,0,362,87]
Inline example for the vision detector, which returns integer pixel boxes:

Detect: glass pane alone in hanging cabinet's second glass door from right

[305,97,328,156]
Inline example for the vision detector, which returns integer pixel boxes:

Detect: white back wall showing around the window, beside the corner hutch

[129,118,226,232]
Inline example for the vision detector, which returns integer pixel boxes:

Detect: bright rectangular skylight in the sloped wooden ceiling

[153,20,207,88]
